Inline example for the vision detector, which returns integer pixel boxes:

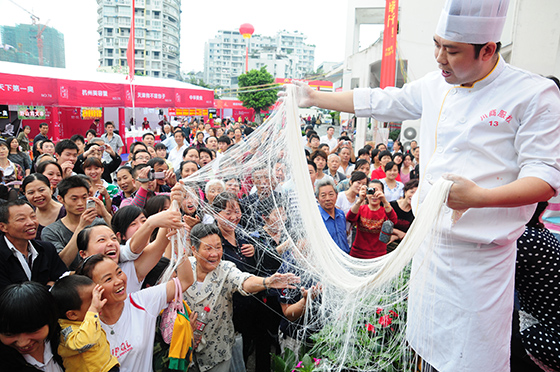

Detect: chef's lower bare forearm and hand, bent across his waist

[444,175,554,210]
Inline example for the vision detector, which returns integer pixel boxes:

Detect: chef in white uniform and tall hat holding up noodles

[290,0,560,372]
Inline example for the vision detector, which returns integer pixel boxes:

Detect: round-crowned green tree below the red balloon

[238,66,278,124]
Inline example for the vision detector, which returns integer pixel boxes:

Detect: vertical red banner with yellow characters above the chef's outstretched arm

[379,0,399,88]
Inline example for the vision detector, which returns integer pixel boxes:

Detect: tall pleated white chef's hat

[436,0,509,44]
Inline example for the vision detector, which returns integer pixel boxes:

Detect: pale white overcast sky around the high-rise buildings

[0,0,379,72]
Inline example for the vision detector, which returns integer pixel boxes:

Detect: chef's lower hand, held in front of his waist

[442,173,486,212]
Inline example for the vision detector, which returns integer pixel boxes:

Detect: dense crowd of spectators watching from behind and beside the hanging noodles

[0,111,428,371]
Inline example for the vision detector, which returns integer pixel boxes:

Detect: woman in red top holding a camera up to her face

[346,180,397,258]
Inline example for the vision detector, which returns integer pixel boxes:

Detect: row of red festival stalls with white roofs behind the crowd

[0,62,214,150]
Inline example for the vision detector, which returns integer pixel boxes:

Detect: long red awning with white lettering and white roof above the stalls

[0,62,214,108]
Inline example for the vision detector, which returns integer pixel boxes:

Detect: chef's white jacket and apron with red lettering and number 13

[354,57,560,372]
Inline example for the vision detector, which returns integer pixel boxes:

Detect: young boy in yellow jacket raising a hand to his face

[51,275,119,372]
